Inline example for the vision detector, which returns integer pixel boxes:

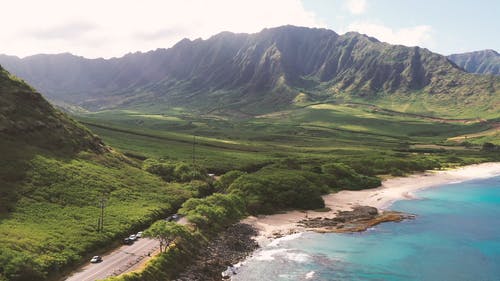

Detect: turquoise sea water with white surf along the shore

[233,177,500,281]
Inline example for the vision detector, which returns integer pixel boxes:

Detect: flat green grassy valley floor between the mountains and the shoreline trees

[77,103,500,173]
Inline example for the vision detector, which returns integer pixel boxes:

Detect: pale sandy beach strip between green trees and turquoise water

[241,162,500,247]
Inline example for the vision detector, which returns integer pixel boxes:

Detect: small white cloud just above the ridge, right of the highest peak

[347,22,434,48]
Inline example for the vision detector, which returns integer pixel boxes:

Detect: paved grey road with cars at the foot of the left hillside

[65,238,160,281]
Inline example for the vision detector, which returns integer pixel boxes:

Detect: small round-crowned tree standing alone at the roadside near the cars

[144,221,189,252]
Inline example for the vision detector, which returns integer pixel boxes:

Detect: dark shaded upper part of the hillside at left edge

[0,67,106,153]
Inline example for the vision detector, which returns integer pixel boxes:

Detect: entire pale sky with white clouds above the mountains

[0,0,500,58]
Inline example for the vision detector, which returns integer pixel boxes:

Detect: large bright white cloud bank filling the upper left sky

[0,0,326,58]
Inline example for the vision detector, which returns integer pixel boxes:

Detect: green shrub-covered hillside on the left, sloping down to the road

[0,68,190,281]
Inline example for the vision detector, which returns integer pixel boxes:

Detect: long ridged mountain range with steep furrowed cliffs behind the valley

[0,26,500,113]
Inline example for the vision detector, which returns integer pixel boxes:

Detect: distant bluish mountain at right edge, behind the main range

[448,50,500,75]
